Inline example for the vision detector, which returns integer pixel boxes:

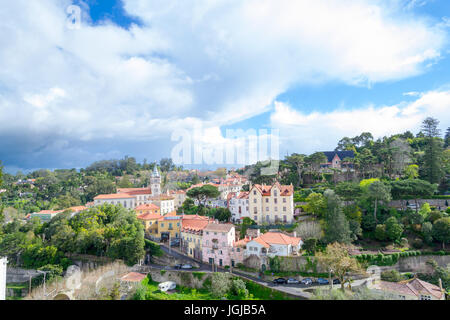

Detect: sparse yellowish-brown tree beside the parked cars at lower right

[316,242,363,291]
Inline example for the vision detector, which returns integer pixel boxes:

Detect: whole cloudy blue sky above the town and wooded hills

[0,0,450,172]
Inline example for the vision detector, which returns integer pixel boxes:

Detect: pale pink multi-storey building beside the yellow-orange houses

[202,223,235,266]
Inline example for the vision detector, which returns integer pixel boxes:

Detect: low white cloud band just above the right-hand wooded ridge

[271,91,450,153]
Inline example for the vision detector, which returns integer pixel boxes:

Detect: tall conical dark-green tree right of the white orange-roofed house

[324,190,351,243]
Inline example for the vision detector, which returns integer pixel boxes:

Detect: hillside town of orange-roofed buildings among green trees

[0,118,450,300]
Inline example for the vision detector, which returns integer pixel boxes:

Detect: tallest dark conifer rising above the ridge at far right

[422,117,443,183]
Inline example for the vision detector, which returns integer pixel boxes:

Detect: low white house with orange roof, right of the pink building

[245,232,303,258]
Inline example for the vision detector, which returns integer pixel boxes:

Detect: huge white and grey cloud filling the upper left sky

[0,0,447,167]
